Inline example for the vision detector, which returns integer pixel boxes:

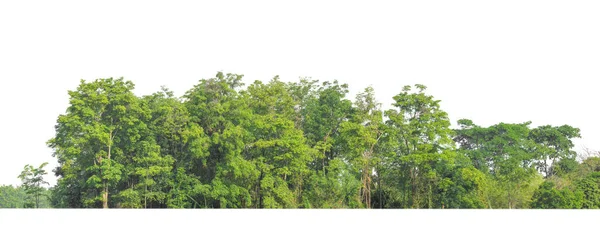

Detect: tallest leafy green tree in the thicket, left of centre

[180,72,251,208]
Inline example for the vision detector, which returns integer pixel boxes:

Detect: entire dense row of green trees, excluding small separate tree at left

[38,73,600,208]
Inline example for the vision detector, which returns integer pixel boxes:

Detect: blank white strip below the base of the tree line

[0,209,600,237]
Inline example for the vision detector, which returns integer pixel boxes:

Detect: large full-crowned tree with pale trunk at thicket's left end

[49,78,148,208]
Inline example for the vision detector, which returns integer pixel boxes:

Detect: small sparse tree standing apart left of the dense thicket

[18,162,48,208]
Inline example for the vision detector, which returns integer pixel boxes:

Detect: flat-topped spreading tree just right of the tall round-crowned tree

[454,119,543,208]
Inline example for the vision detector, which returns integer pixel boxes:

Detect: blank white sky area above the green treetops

[0,0,600,190]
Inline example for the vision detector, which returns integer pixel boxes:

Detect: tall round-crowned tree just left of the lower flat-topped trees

[384,84,456,208]
